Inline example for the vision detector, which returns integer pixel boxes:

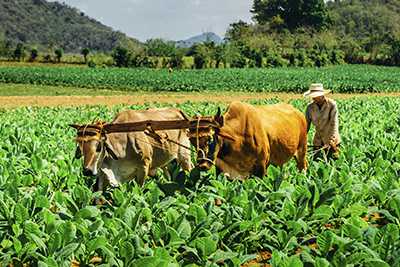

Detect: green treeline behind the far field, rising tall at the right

[0,0,400,69]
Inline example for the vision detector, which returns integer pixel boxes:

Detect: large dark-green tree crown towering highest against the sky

[251,0,330,30]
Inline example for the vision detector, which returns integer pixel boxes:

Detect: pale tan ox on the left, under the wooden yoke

[71,108,192,191]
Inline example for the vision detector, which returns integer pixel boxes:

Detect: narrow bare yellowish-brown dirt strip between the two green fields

[0,92,400,108]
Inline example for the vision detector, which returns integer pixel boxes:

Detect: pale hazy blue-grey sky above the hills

[57,0,253,41]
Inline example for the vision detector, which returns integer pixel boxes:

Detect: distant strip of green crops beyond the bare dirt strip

[0,65,400,93]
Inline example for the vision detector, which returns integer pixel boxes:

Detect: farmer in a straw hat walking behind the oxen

[303,83,340,159]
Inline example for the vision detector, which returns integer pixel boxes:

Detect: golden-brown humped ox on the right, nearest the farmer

[189,102,307,179]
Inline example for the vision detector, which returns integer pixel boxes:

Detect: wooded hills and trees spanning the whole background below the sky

[0,0,400,69]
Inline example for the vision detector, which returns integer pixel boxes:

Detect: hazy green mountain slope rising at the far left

[0,0,139,52]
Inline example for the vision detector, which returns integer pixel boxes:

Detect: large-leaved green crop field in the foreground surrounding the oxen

[0,97,400,267]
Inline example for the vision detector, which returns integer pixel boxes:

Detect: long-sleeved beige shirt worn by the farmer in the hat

[306,97,341,146]
